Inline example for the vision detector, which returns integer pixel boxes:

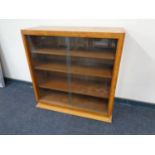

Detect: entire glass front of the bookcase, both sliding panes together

[27,36,117,114]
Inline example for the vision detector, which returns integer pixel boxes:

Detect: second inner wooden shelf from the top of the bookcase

[35,62,112,79]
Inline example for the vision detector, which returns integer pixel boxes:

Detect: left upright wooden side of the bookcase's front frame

[21,31,39,102]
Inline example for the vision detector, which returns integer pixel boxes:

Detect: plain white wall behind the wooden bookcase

[0,19,155,104]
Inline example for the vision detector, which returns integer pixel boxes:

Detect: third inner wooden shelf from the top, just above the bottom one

[39,78,109,98]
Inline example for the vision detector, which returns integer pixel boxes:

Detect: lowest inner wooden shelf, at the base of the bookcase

[39,92,107,115]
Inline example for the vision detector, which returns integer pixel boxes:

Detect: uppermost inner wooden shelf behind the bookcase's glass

[32,48,115,60]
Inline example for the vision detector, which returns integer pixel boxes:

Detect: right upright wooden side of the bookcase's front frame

[108,34,125,116]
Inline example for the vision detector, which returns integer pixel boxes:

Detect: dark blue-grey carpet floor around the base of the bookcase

[0,81,155,135]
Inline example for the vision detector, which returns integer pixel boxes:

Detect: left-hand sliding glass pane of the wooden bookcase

[27,36,69,104]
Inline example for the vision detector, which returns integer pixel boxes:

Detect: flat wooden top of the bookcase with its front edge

[22,26,125,37]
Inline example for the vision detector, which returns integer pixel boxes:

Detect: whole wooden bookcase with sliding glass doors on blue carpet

[21,27,125,122]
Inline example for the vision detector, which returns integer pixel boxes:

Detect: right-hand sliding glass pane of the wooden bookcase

[70,38,117,113]
